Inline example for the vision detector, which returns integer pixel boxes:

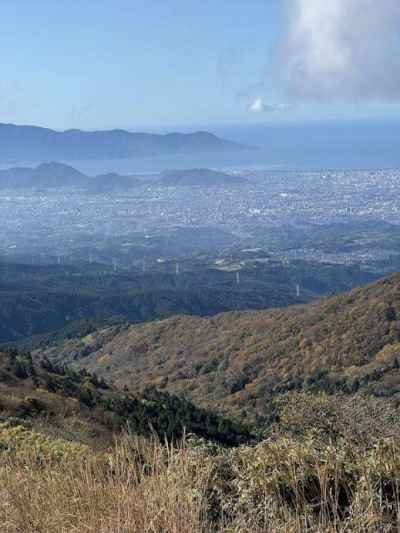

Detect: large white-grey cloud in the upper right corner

[281,0,400,101]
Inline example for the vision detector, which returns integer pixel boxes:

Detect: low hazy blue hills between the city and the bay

[0,162,248,193]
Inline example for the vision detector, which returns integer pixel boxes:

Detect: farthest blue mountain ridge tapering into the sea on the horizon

[0,124,249,161]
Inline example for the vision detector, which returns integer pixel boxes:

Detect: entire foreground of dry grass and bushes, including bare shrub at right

[0,393,400,533]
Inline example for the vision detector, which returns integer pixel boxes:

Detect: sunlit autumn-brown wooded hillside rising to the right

[41,274,400,416]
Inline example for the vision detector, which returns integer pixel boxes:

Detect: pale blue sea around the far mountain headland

[1,120,400,175]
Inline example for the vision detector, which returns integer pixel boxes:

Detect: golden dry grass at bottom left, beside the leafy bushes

[0,439,211,533]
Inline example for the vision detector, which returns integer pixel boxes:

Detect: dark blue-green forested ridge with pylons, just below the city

[0,260,374,346]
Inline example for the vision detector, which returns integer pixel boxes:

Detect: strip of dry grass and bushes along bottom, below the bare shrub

[0,432,400,533]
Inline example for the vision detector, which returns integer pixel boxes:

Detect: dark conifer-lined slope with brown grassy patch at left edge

[0,352,251,448]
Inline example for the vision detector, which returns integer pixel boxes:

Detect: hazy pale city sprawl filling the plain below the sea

[0,170,400,267]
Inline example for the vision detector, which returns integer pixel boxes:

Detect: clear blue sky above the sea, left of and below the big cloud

[0,0,398,129]
